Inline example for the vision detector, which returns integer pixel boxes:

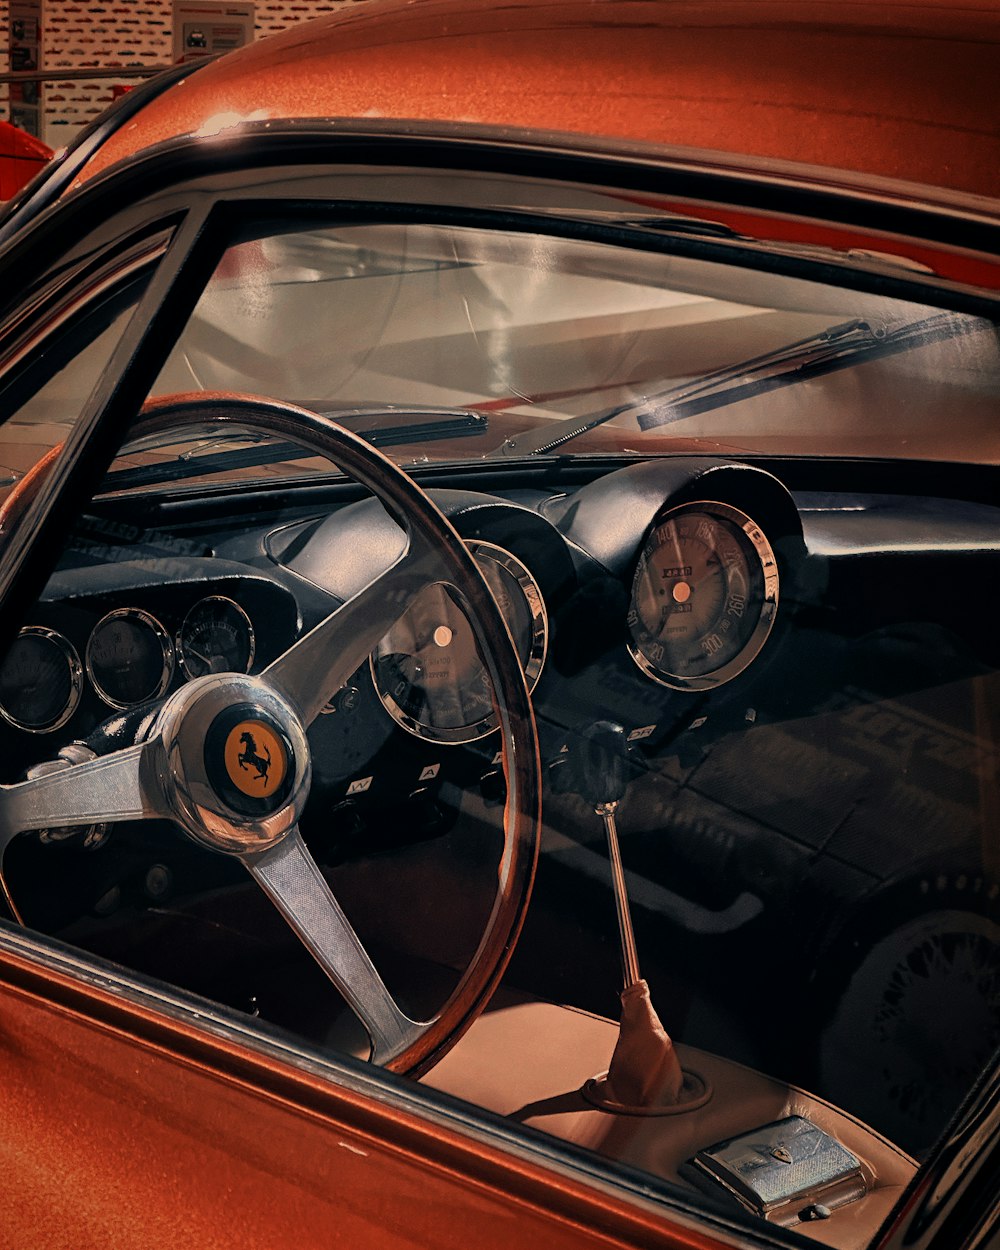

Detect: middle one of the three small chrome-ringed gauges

[86,608,174,708]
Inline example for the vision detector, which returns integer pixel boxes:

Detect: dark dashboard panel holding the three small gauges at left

[0,562,300,754]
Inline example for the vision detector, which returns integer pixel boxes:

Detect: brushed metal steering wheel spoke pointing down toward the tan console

[250,828,426,1063]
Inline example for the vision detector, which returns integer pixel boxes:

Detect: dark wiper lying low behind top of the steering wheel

[101,406,489,494]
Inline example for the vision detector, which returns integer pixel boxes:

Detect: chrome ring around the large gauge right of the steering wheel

[626,500,780,691]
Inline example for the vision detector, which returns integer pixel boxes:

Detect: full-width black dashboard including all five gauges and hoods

[0,458,1000,825]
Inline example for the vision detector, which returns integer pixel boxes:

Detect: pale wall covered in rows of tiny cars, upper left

[0,0,365,148]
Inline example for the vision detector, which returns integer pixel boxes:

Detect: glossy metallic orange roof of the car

[76,0,1000,211]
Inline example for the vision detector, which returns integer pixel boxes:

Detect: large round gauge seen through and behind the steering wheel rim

[371,543,549,743]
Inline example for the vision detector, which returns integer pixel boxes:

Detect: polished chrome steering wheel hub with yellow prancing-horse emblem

[153,674,311,856]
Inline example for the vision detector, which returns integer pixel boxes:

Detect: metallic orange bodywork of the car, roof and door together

[0,0,1000,1250]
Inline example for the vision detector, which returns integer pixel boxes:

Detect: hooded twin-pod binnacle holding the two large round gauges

[269,461,801,775]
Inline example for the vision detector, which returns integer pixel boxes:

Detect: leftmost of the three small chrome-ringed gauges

[0,625,84,734]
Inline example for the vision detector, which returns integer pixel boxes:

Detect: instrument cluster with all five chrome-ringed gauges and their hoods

[0,465,789,775]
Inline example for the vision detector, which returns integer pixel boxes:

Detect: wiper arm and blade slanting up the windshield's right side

[496,313,981,456]
